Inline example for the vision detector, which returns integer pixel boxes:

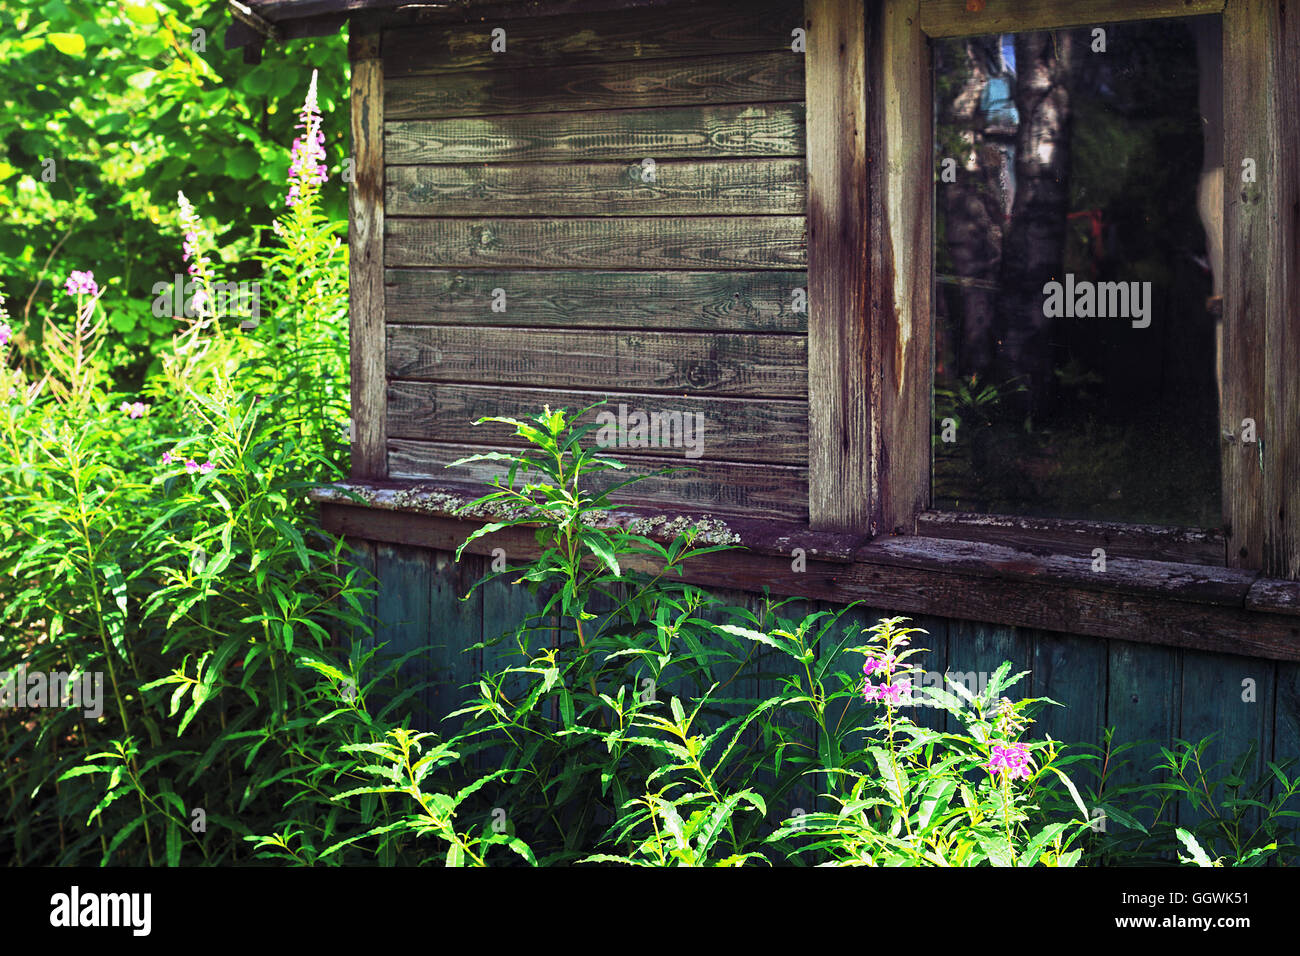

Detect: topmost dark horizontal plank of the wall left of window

[384,0,803,77]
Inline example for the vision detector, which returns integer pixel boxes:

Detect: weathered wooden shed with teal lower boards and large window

[228,0,1300,790]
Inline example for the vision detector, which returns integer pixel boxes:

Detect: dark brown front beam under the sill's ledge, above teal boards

[317,496,1300,661]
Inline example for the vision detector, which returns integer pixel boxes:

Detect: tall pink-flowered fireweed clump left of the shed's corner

[0,74,462,865]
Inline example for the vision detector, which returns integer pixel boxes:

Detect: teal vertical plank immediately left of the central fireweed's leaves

[430,551,484,737]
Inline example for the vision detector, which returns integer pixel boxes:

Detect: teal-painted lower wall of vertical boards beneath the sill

[356,541,1300,827]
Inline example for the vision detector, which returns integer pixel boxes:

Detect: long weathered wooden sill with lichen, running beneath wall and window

[312,481,1300,661]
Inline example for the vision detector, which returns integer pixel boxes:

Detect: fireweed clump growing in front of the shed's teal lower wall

[403,408,1289,866]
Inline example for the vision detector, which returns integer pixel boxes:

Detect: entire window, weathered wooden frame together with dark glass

[807,0,1300,579]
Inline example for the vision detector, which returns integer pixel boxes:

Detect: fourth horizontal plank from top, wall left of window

[385,159,807,216]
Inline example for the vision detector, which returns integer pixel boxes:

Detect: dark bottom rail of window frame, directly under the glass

[917,511,1225,567]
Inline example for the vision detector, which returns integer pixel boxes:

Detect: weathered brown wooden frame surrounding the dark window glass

[805,0,1300,580]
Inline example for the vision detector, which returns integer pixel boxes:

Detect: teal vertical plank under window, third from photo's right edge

[1097,641,1182,826]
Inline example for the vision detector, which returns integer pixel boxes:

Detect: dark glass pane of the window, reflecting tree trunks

[932,17,1222,528]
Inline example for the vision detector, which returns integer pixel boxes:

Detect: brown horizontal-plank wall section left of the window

[381,0,807,519]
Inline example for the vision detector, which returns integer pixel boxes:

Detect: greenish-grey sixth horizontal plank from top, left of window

[385,269,807,332]
